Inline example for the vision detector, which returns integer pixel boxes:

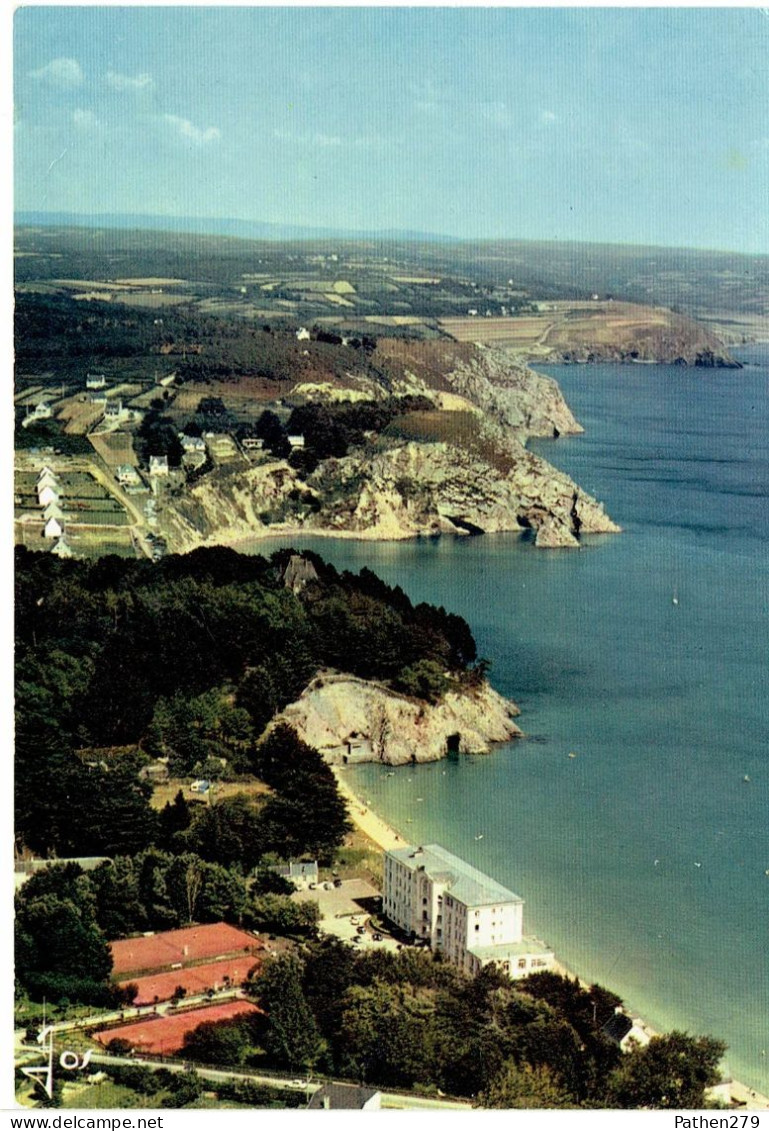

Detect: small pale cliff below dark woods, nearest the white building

[273,674,521,766]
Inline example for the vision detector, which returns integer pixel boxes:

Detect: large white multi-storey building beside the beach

[382,845,555,978]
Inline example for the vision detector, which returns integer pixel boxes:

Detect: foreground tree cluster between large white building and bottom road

[179,938,724,1108]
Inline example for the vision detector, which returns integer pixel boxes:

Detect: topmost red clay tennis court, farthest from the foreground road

[110,923,260,975]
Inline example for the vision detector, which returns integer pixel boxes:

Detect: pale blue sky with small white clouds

[14,6,769,252]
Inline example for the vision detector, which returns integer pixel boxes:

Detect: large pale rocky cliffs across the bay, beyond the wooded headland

[165,343,619,549]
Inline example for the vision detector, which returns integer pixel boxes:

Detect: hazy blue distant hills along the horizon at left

[14,211,460,243]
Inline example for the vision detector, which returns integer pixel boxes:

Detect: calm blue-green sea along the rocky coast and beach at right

[246,347,769,1091]
